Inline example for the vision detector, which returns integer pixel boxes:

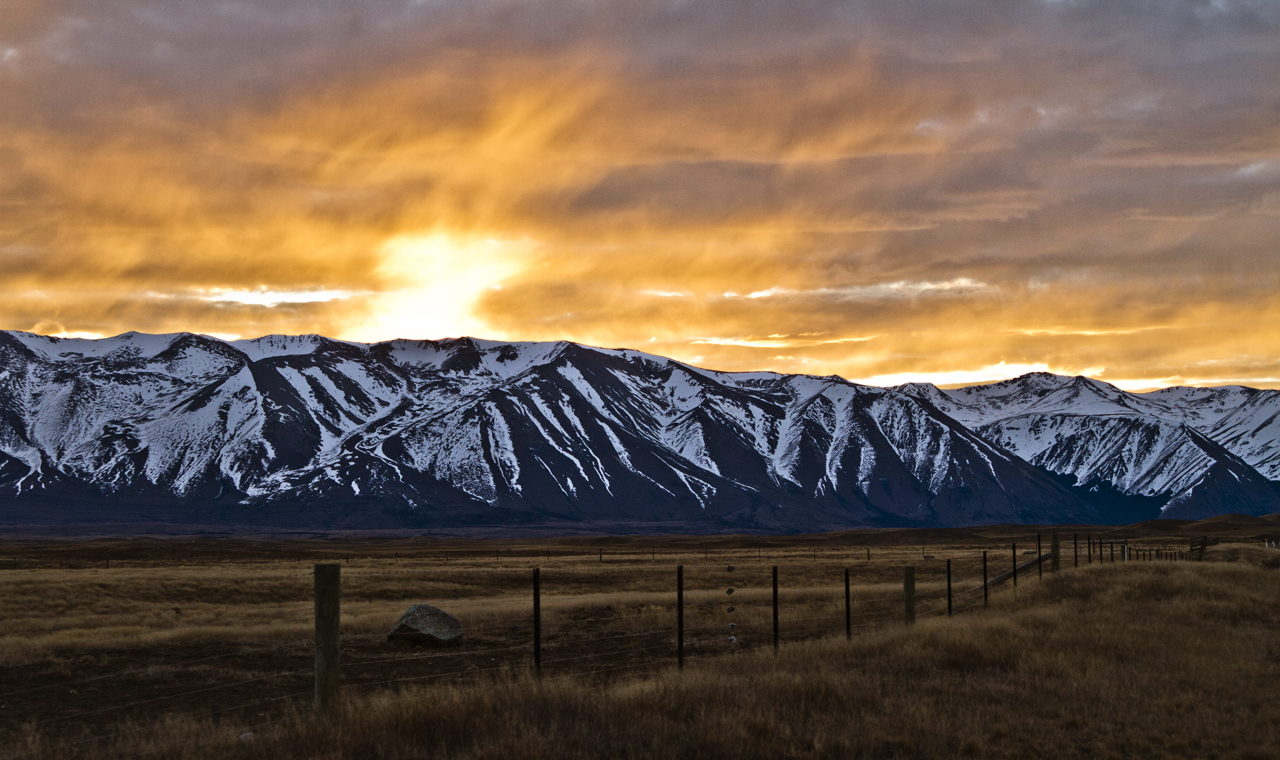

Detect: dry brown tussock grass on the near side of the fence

[0,546,1280,760]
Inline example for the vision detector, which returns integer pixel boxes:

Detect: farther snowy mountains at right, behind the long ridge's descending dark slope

[899,372,1280,518]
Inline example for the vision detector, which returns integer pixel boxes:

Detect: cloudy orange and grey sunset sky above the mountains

[0,0,1280,389]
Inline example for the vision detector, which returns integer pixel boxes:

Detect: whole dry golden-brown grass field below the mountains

[0,521,1280,760]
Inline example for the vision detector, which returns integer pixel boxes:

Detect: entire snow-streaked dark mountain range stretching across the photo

[0,331,1280,532]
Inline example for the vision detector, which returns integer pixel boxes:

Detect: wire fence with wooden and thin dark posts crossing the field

[0,534,1208,747]
